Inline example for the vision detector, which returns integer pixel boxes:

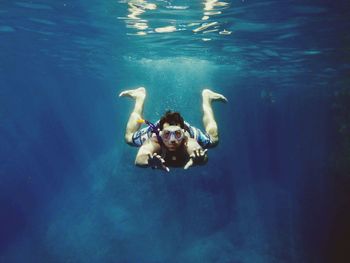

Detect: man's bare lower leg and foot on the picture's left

[119,87,146,144]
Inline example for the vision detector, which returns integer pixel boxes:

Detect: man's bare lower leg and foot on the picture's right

[202,89,227,147]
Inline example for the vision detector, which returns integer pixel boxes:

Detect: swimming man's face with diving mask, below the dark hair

[161,122,184,151]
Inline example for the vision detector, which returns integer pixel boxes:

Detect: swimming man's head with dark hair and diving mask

[159,111,185,151]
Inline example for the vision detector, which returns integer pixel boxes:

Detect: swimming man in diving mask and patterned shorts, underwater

[119,87,227,172]
